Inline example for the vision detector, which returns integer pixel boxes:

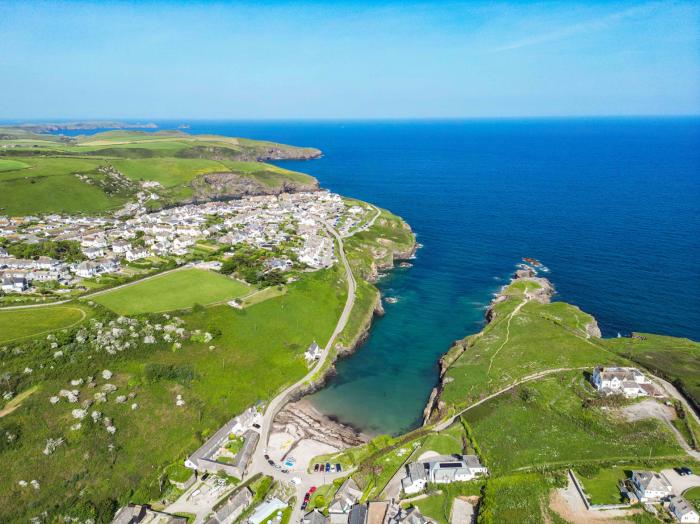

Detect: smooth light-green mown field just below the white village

[94,269,251,315]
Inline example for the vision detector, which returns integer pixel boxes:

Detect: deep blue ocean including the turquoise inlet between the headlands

[45,118,700,433]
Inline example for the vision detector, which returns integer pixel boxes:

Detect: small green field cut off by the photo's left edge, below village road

[0,305,86,344]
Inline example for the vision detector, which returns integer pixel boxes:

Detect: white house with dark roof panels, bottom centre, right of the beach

[401,455,488,495]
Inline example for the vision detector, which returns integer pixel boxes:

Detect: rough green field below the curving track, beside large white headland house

[464,372,684,474]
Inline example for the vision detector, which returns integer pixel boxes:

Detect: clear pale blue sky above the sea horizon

[0,0,700,119]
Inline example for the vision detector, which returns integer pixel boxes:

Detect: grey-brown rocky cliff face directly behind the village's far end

[186,172,319,201]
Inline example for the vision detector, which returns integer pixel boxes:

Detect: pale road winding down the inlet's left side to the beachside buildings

[166,223,357,524]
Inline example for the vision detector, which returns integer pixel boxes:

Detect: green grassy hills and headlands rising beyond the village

[0,128,320,215]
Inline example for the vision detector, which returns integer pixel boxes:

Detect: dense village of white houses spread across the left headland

[0,191,363,293]
